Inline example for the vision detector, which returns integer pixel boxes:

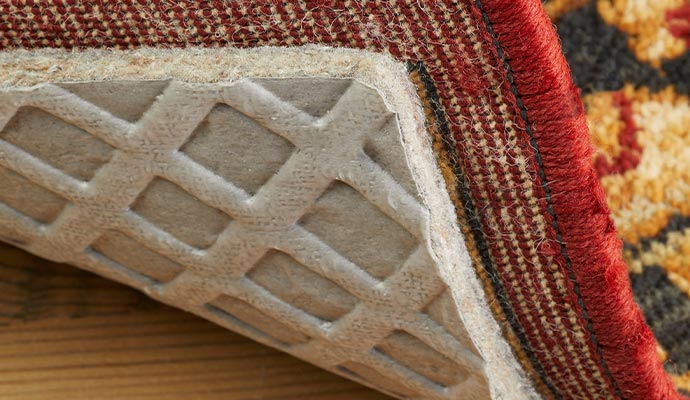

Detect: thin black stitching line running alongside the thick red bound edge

[475,0,623,399]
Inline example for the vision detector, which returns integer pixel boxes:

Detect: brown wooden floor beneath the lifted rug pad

[0,244,388,400]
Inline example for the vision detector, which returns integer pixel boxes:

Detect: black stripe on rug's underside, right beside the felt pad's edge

[408,61,562,400]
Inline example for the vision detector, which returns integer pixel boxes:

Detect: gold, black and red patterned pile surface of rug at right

[546,0,690,393]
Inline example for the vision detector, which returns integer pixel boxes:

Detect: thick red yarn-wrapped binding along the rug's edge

[483,0,681,399]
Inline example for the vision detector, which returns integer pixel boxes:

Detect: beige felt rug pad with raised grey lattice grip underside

[0,46,536,399]
